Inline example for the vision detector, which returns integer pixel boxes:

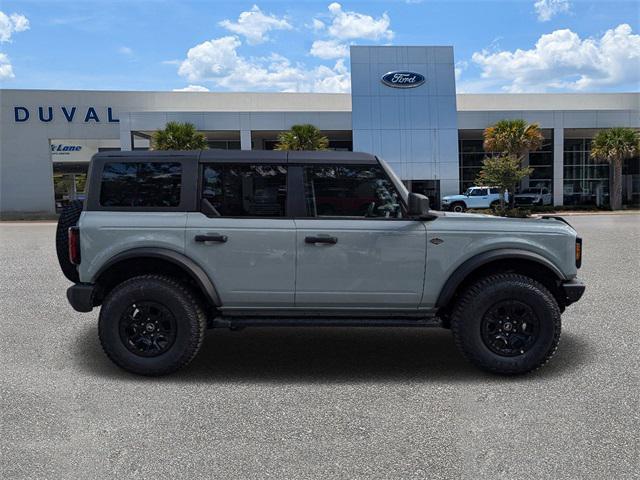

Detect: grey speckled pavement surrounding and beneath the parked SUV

[0,215,640,480]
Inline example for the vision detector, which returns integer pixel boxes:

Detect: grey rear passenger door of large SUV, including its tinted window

[185,158,296,309]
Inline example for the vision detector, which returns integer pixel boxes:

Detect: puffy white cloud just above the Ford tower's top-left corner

[328,2,394,40]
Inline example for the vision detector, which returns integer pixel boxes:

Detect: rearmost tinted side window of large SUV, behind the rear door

[100,162,182,208]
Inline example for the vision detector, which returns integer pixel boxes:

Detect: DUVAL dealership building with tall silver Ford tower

[0,46,640,216]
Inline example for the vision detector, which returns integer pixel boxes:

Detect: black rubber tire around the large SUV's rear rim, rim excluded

[98,275,207,376]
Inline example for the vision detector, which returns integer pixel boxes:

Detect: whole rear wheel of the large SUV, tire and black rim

[98,275,206,375]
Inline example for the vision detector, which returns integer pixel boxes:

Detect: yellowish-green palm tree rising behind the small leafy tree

[483,119,544,207]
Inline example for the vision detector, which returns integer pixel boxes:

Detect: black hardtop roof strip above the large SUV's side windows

[94,149,378,164]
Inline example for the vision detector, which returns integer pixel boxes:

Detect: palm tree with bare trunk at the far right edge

[590,127,640,210]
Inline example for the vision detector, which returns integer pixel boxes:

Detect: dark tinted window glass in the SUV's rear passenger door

[202,164,287,217]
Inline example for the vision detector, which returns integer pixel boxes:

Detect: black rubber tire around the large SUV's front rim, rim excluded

[451,273,561,375]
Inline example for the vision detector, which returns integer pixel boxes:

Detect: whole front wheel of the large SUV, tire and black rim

[451,274,561,375]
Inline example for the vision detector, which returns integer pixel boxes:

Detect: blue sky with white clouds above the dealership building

[0,0,640,93]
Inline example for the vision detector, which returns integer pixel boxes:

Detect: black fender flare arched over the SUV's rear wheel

[91,247,222,307]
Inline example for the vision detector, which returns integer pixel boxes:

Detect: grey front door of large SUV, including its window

[295,165,426,309]
